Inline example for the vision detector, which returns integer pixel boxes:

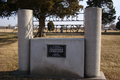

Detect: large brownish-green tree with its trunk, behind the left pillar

[0,0,83,37]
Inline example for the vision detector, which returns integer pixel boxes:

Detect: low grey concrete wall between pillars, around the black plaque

[30,38,84,78]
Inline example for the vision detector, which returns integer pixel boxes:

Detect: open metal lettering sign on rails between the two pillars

[33,13,84,33]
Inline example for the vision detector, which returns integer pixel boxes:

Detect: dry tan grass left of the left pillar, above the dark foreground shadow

[0,33,18,71]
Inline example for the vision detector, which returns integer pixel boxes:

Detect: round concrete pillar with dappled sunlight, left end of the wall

[18,9,33,73]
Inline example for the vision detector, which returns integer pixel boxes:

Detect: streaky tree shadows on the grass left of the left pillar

[0,32,18,46]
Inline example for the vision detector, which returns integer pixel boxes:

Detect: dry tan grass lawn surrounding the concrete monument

[0,31,120,80]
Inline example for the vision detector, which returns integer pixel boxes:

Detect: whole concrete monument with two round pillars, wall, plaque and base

[18,8,106,80]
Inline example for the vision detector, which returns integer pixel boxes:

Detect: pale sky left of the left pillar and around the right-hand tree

[0,0,120,26]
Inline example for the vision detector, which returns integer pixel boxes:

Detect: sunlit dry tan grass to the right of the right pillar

[101,35,120,80]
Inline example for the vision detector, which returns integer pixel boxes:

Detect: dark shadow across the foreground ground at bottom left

[0,71,67,80]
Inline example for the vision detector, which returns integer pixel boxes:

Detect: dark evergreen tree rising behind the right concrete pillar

[87,0,116,25]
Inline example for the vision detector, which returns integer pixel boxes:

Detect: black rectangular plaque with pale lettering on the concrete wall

[47,45,66,57]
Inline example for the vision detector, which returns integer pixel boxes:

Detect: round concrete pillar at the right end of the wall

[85,8,102,77]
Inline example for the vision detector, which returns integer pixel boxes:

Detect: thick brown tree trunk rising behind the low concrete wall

[35,15,45,37]
